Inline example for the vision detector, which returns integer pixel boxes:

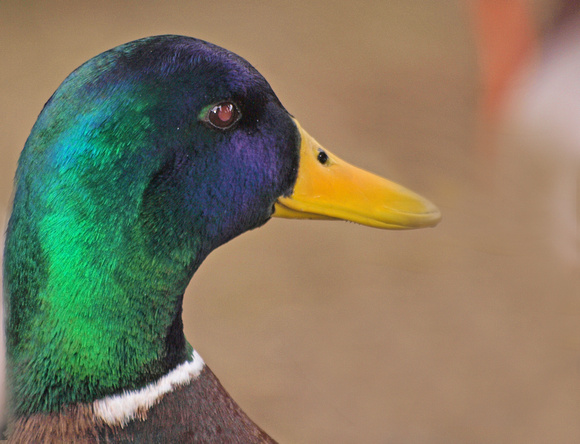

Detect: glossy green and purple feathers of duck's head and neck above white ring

[5,36,299,414]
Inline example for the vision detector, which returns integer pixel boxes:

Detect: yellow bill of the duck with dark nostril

[274,122,441,230]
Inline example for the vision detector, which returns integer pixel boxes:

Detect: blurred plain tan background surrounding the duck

[0,0,580,444]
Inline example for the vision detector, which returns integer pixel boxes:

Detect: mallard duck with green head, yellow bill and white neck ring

[4,35,440,443]
